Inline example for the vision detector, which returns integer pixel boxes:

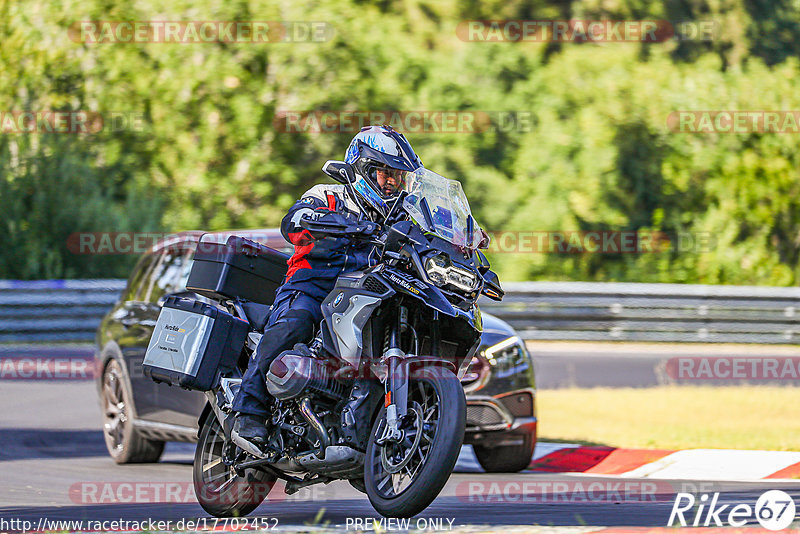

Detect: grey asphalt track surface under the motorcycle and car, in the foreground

[0,380,800,530]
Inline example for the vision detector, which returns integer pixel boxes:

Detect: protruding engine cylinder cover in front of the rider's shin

[267,350,346,400]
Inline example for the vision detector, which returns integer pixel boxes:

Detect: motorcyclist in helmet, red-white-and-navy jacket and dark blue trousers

[233,125,422,448]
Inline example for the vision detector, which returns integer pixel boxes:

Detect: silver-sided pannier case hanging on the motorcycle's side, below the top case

[142,297,249,391]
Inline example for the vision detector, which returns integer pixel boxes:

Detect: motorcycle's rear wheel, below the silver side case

[192,412,275,517]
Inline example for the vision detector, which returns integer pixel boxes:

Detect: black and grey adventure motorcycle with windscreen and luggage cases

[144,161,503,517]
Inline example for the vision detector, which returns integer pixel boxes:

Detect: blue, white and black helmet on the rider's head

[344,125,422,215]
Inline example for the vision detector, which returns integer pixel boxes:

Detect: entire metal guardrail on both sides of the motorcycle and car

[0,280,800,344]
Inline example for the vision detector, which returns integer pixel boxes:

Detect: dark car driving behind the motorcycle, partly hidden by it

[95,230,536,472]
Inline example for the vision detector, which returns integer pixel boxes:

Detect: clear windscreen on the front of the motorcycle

[403,168,480,248]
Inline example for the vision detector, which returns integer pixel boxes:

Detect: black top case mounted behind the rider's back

[186,236,289,304]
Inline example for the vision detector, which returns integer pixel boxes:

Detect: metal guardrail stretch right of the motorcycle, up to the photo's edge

[481,282,800,344]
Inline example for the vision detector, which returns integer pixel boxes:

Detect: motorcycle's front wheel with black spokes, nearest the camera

[364,367,466,517]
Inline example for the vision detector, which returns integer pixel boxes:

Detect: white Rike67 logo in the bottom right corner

[667,490,795,530]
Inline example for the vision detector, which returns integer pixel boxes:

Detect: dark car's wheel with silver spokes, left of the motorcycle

[100,359,164,464]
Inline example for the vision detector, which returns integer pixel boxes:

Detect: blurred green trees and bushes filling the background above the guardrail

[0,0,800,285]
